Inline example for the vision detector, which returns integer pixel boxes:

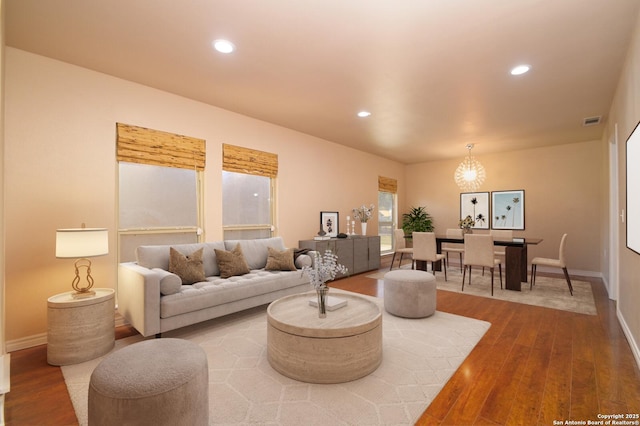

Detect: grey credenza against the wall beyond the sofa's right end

[298,235,380,278]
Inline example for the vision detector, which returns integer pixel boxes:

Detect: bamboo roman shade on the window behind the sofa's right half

[222,144,278,178]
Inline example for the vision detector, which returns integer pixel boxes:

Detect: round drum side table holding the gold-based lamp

[47,288,115,365]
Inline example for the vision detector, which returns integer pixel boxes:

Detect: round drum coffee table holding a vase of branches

[267,291,382,383]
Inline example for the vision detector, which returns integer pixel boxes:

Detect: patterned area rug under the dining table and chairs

[367,265,598,315]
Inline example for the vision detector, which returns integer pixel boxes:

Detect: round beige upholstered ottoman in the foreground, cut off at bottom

[88,339,209,426]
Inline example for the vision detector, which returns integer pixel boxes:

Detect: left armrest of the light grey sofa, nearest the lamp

[118,262,161,337]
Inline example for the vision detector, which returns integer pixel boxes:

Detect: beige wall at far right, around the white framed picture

[604,7,640,364]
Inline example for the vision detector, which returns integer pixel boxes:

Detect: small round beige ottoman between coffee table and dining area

[384,269,436,318]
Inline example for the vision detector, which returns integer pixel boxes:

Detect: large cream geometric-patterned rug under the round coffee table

[62,289,491,426]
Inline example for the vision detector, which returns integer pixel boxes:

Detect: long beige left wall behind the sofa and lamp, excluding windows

[5,48,404,347]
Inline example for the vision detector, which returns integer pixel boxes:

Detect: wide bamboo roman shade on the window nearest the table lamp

[116,123,206,171]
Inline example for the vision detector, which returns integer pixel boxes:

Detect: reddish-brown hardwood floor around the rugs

[5,262,640,426]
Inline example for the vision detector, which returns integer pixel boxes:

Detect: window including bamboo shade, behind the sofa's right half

[222,144,278,240]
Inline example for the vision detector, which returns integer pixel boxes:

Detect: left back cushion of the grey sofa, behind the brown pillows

[136,241,225,277]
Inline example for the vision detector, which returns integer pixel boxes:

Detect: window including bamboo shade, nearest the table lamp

[116,123,205,262]
